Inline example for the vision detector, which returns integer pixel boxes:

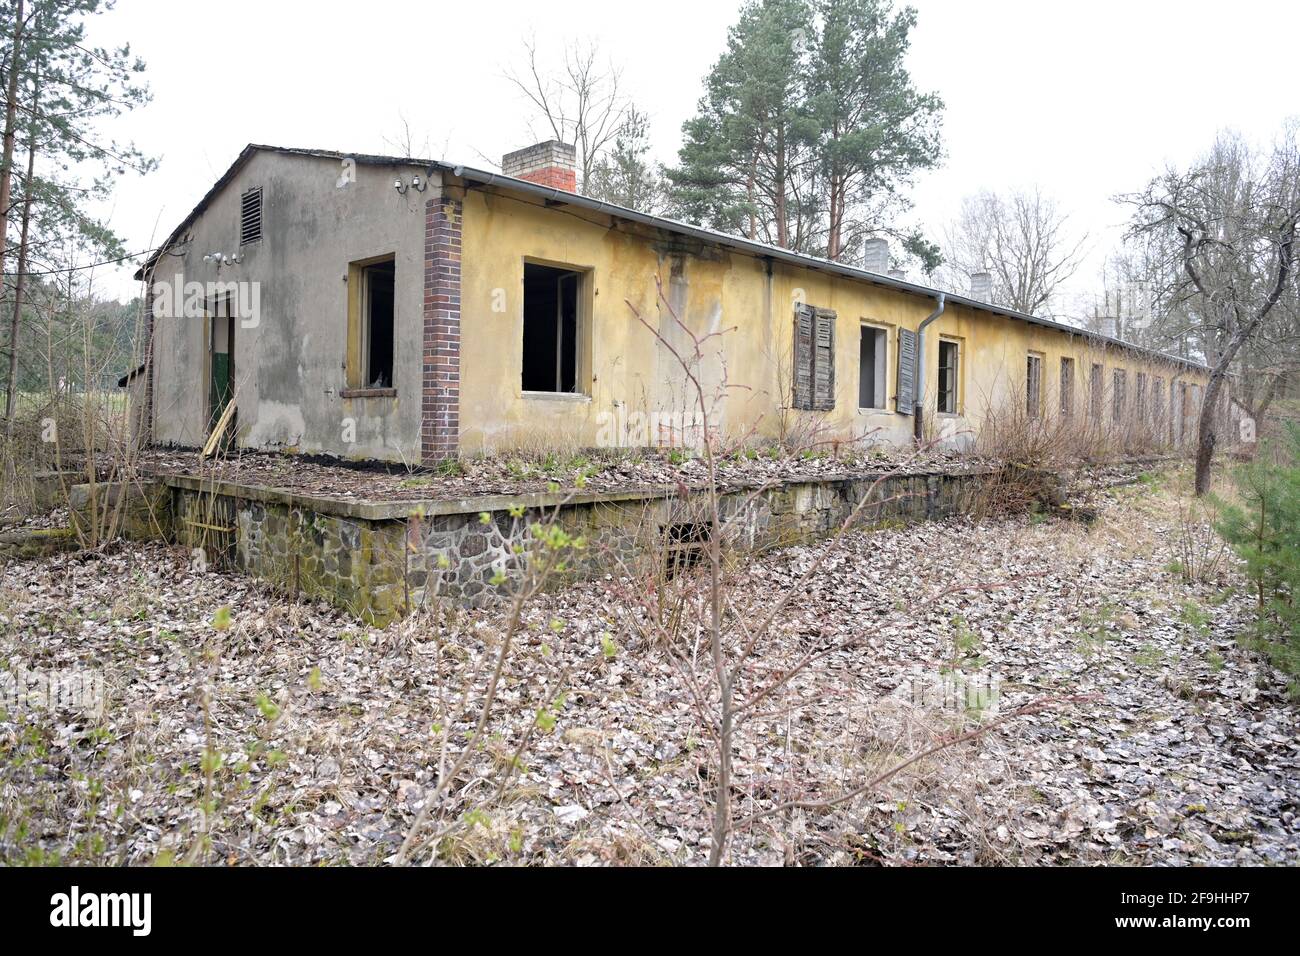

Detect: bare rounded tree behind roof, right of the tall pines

[943,189,1088,315]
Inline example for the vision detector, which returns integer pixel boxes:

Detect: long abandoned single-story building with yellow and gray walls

[124,142,1208,464]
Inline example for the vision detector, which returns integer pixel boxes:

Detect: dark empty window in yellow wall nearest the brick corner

[524,263,582,392]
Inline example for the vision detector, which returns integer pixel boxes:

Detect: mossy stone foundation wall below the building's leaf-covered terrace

[129,471,985,624]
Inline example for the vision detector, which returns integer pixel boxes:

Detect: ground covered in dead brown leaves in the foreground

[0,468,1300,865]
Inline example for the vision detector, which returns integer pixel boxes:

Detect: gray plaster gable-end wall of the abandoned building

[153,152,441,462]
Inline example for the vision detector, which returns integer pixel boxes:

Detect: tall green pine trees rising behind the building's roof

[668,0,943,271]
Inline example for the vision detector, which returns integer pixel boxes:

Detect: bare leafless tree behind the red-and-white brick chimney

[506,38,628,191]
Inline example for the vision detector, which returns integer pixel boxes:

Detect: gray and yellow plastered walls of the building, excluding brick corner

[153,151,1205,464]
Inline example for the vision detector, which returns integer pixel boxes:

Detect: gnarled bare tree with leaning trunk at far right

[1127,124,1300,496]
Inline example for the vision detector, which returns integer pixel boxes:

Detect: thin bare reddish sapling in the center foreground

[621,276,1084,866]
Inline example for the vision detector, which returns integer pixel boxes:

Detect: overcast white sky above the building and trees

[91,0,1300,306]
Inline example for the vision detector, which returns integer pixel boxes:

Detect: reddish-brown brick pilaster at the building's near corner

[420,198,462,464]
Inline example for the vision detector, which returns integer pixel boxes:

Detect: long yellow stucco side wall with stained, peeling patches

[450,185,1205,454]
